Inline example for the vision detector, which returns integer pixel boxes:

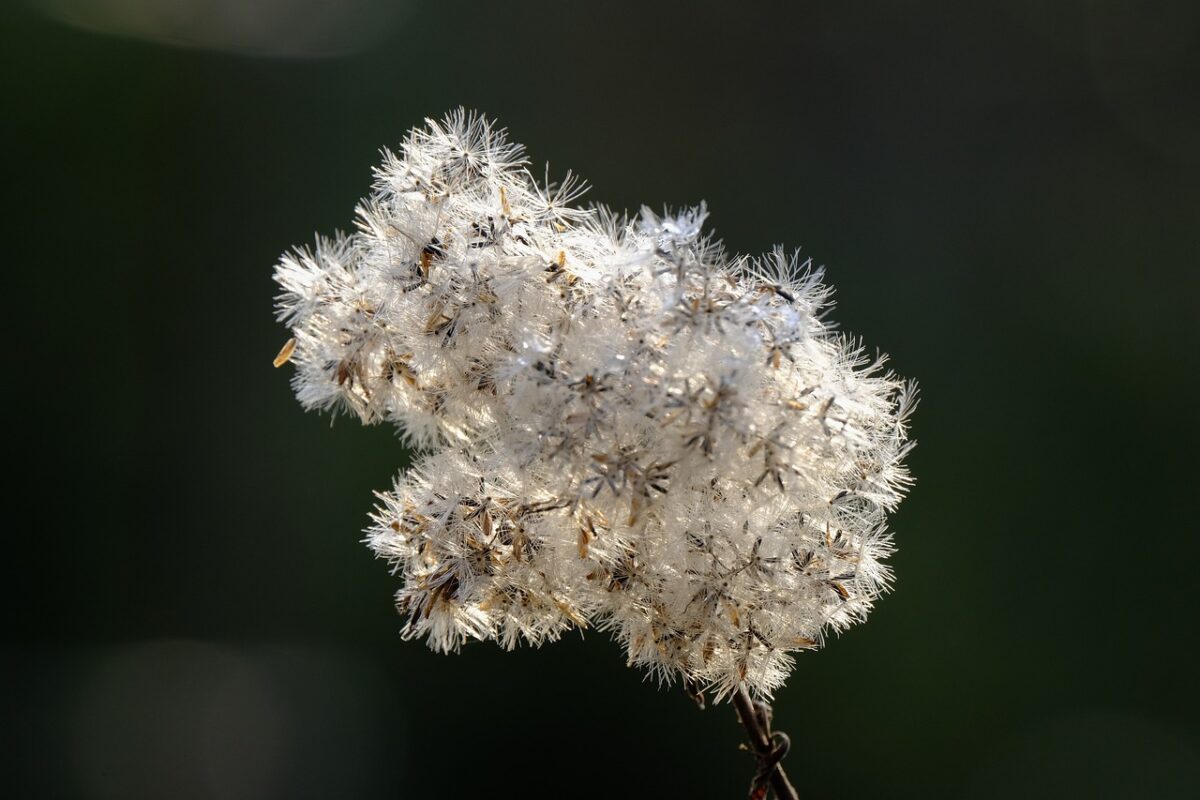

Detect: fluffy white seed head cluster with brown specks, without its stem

[276,112,913,694]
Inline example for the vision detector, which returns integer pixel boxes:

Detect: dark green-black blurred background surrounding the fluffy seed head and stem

[0,0,1200,800]
